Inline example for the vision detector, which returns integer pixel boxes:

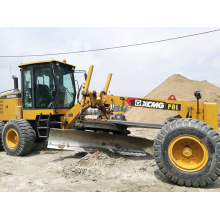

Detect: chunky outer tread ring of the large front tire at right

[154,118,220,187]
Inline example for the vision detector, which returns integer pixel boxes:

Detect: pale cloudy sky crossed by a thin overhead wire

[0,27,220,97]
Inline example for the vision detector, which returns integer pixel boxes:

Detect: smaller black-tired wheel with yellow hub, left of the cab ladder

[2,119,36,156]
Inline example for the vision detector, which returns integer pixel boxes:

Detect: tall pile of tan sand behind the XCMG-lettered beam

[125,74,220,123]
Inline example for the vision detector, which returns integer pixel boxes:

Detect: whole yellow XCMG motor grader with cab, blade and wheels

[0,60,220,187]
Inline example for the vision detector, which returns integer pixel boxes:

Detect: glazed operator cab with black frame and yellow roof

[19,60,76,109]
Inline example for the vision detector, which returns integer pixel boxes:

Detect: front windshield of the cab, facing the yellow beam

[56,65,75,108]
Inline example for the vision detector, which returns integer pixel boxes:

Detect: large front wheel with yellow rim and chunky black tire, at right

[154,119,220,187]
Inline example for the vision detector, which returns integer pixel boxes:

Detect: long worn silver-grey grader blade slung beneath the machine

[47,129,153,154]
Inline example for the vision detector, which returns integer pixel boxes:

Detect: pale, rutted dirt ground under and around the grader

[0,128,220,192]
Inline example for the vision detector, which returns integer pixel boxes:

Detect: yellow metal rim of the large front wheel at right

[168,135,209,172]
